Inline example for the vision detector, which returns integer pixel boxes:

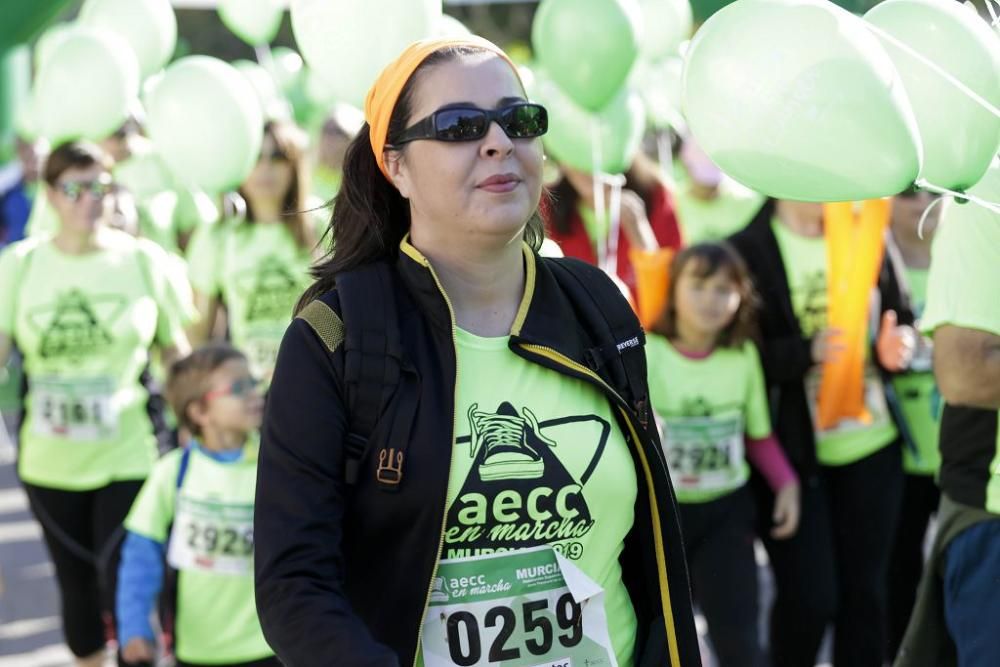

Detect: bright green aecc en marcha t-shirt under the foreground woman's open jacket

[424,329,638,667]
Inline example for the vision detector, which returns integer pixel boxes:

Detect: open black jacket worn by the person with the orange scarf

[729,200,913,482]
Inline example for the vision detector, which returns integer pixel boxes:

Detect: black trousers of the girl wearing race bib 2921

[680,487,761,667]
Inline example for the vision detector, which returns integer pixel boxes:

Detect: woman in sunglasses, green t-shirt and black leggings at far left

[0,142,188,666]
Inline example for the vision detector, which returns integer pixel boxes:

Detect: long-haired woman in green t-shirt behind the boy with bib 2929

[188,121,318,383]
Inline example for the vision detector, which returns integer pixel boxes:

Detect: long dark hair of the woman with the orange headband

[295,46,545,313]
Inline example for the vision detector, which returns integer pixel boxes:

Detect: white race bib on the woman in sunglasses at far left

[31,377,118,441]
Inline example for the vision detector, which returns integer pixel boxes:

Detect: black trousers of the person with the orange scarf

[757,443,903,667]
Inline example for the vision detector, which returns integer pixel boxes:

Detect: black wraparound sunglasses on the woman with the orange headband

[391,102,549,146]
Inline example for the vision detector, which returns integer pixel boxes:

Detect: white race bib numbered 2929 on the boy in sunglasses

[167,496,253,575]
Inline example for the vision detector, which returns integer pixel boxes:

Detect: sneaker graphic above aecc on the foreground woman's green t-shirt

[469,401,556,482]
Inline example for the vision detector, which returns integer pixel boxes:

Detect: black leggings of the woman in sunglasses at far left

[24,481,142,658]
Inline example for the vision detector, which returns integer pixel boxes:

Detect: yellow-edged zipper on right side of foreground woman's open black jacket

[519,343,681,666]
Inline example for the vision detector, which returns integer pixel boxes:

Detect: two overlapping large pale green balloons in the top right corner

[683,0,1000,201]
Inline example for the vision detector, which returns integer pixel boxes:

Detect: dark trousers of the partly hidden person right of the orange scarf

[886,475,941,661]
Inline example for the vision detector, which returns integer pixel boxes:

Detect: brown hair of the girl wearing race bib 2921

[651,241,757,347]
